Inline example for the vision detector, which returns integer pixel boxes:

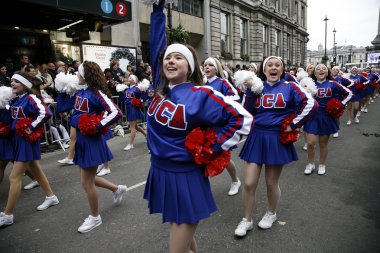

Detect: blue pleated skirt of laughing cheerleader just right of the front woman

[239,125,298,165]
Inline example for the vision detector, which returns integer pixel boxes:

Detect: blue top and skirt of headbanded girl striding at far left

[10,93,52,162]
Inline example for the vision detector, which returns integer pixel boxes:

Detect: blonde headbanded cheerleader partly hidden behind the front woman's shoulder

[203,57,241,196]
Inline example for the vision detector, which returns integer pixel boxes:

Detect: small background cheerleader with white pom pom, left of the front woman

[116,75,146,151]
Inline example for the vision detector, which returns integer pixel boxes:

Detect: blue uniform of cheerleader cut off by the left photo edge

[0,108,14,161]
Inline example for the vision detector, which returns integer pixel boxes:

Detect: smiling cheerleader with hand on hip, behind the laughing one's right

[304,64,352,175]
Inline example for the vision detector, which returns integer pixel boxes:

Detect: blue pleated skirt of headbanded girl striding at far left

[13,134,41,162]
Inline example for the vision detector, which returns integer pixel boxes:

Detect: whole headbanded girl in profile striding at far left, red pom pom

[0,71,59,226]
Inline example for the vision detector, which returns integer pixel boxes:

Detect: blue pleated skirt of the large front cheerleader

[144,156,217,224]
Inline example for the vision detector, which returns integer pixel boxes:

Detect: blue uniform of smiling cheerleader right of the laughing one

[303,80,353,135]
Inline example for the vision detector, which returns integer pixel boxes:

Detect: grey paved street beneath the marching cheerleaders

[0,101,380,253]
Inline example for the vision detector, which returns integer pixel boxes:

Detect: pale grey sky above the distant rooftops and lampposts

[307,0,380,50]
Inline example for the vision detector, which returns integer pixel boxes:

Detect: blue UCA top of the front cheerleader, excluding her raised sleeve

[147,83,253,162]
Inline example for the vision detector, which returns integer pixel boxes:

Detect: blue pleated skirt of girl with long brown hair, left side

[74,129,113,169]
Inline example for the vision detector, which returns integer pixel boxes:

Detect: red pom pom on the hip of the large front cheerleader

[185,127,231,177]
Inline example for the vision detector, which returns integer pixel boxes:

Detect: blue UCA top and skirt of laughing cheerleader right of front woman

[239,80,318,165]
